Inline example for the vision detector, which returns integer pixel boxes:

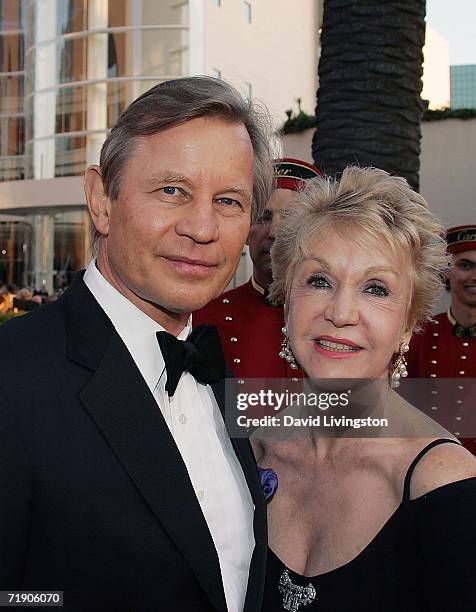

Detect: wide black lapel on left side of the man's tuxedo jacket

[60,279,226,611]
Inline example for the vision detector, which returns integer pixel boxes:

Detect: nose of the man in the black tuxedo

[175,196,219,244]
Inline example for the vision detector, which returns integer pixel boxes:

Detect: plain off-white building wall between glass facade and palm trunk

[204,0,320,127]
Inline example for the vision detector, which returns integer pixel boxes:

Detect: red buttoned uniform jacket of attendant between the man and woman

[193,280,303,378]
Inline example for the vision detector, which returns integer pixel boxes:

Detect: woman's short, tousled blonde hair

[270,166,449,328]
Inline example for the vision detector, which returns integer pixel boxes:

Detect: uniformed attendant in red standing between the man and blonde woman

[193,158,320,378]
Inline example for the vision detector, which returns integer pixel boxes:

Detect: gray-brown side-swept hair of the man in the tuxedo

[91,76,273,255]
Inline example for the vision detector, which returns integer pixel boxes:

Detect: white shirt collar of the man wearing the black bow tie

[83,259,192,392]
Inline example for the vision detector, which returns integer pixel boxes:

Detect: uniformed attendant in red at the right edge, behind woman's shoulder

[407,224,476,454]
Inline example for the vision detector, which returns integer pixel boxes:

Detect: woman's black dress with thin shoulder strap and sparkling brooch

[263,440,476,612]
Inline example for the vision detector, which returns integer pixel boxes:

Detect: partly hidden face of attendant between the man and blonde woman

[247,189,296,287]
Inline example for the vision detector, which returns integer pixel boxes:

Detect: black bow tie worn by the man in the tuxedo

[157,325,226,397]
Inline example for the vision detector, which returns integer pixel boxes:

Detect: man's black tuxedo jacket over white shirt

[0,275,266,612]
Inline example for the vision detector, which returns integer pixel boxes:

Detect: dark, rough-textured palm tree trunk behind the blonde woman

[312,0,425,189]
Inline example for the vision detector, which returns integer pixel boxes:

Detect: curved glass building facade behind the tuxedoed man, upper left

[0,0,189,291]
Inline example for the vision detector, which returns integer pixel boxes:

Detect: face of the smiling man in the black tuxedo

[96,118,253,313]
